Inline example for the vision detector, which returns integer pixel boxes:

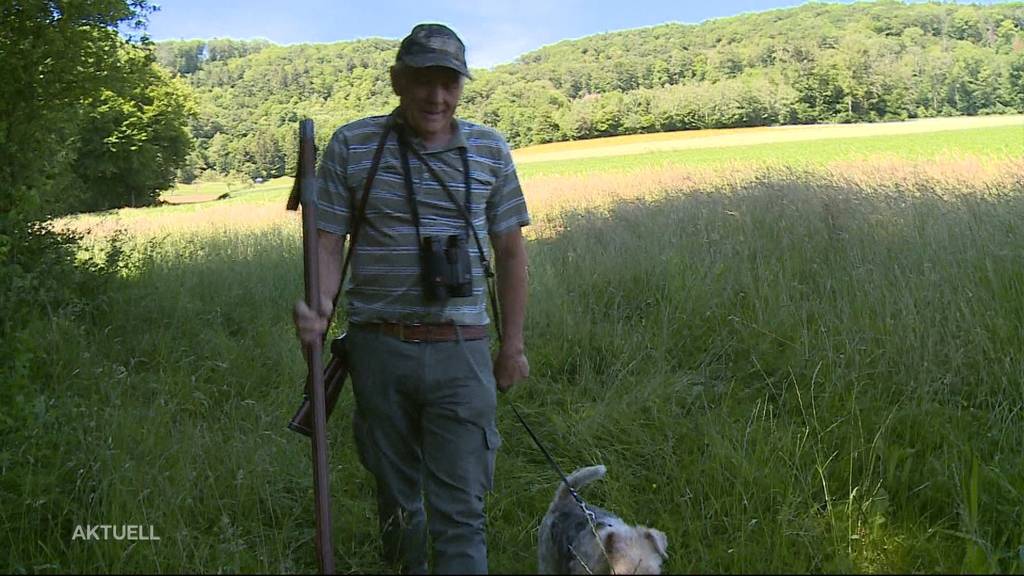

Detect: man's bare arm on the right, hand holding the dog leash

[490,227,529,392]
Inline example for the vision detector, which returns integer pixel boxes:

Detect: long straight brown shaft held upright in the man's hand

[287,119,340,574]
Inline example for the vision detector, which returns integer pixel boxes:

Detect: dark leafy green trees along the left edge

[0,0,198,387]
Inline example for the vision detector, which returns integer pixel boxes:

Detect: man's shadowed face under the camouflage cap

[391,66,463,141]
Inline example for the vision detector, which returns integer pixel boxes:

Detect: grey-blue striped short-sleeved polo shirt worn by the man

[316,109,529,325]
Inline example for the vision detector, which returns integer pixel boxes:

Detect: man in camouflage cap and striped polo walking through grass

[295,25,529,574]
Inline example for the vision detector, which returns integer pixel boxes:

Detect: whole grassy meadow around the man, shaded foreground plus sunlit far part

[8,115,1024,573]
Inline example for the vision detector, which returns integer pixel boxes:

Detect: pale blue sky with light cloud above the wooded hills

[147,0,1007,68]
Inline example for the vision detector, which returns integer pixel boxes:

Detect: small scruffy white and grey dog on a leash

[538,465,669,574]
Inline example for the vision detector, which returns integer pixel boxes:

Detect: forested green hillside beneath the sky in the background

[156,1,1024,181]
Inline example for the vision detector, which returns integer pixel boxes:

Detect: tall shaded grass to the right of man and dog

[511,165,1024,572]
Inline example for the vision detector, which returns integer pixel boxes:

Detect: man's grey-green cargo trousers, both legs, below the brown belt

[348,326,501,574]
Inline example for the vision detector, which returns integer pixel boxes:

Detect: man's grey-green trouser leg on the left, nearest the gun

[349,330,427,574]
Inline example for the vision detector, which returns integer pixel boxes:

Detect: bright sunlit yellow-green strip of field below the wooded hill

[56,117,1024,236]
